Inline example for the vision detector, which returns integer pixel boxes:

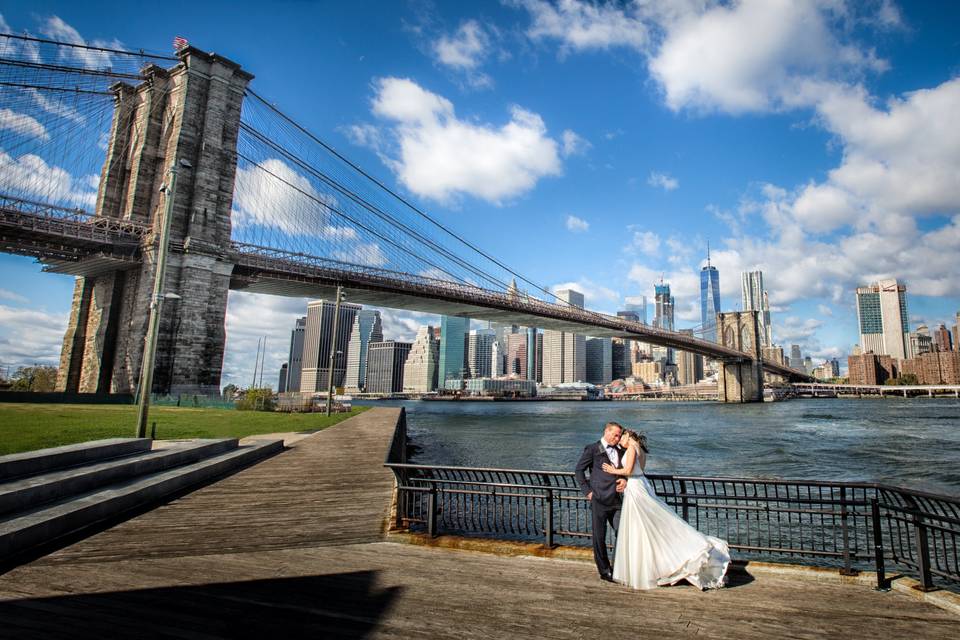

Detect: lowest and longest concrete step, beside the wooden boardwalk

[0,440,283,563]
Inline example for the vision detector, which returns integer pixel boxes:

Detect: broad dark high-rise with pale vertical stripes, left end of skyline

[300,300,361,393]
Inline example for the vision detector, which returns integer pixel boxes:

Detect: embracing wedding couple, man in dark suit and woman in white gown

[576,422,730,589]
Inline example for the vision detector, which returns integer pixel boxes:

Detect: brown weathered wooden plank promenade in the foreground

[0,408,960,639]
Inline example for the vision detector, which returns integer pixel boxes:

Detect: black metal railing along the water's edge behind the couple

[386,413,960,590]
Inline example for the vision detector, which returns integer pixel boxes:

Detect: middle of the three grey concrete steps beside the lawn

[0,438,237,520]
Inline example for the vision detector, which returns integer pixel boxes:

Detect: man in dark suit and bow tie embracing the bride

[576,422,627,582]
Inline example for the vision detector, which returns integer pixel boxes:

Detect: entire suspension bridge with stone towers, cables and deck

[0,34,809,402]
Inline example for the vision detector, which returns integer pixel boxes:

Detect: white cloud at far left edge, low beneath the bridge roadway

[0,304,67,373]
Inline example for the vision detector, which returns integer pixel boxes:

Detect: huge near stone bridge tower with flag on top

[57,47,253,395]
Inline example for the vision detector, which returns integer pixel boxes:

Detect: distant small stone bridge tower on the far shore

[717,311,763,403]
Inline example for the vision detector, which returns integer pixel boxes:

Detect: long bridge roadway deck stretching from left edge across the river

[0,194,812,380]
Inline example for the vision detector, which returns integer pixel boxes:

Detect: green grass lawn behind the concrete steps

[0,403,369,455]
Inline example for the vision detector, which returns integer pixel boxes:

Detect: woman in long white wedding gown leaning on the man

[603,429,730,589]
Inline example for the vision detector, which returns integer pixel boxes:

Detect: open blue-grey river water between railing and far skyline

[357,398,960,496]
